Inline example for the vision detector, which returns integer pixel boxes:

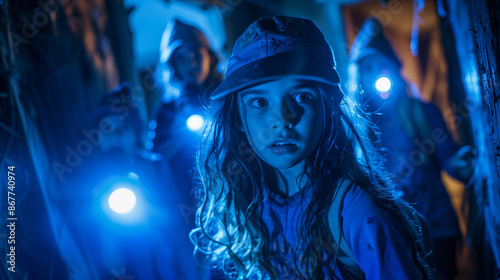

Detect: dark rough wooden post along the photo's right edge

[446,0,500,279]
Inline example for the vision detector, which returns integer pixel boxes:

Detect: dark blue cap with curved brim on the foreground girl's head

[211,16,340,99]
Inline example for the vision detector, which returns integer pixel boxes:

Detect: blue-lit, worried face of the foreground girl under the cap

[238,78,325,169]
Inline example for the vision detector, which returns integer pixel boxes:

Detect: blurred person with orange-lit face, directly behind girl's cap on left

[150,20,222,278]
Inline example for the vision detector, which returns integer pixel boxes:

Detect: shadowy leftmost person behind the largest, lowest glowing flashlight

[65,84,191,279]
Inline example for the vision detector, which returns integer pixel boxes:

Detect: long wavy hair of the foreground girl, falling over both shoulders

[191,83,432,279]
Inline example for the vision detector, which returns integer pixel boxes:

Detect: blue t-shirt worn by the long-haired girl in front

[262,185,423,279]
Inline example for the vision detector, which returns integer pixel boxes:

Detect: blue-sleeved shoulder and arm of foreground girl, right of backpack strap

[329,180,423,279]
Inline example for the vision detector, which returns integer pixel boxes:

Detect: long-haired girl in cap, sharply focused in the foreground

[191,16,432,279]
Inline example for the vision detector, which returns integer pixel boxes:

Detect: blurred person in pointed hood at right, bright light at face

[349,19,474,279]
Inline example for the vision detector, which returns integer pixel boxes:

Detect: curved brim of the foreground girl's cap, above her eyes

[210,56,340,100]
